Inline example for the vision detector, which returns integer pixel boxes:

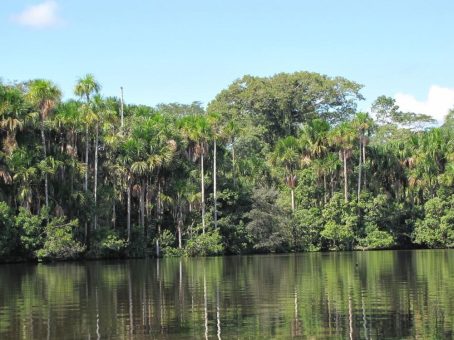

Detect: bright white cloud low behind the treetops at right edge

[394,85,454,123]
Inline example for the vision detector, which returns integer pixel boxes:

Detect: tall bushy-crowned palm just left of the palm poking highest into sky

[27,79,61,206]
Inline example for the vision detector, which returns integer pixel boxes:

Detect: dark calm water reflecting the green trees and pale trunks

[0,250,454,340]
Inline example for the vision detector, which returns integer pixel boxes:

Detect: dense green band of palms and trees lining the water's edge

[0,72,454,262]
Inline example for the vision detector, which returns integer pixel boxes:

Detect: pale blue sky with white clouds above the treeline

[0,0,454,121]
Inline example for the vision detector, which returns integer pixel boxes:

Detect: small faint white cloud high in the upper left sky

[12,0,63,28]
